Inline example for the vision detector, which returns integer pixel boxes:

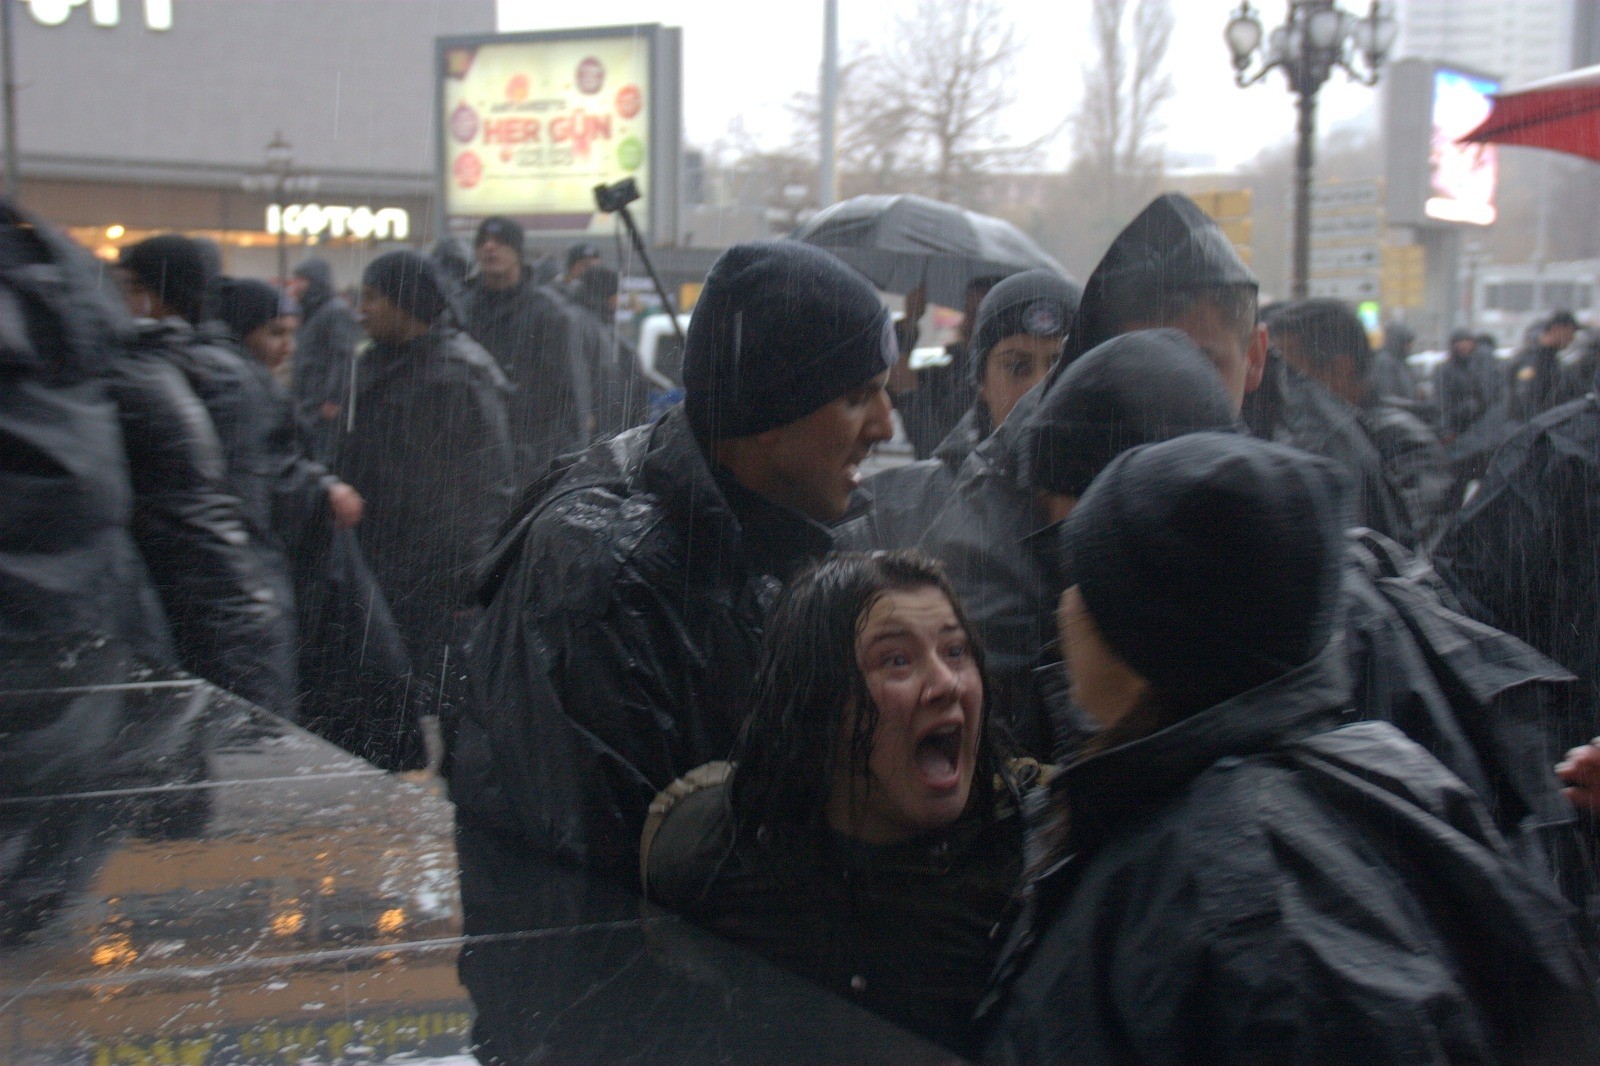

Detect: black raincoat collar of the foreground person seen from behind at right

[1050,634,1350,848]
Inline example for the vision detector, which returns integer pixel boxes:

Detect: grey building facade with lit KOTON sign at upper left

[5,0,494,282]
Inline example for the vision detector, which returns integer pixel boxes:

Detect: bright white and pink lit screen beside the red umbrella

[1422,67,1499,226]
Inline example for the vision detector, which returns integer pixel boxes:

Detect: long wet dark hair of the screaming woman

[728,551,1002,834]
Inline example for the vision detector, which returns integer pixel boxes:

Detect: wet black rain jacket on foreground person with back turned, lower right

[987,645,1600,1066]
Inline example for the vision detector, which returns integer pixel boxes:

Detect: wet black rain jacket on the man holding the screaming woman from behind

[450,407,832,885]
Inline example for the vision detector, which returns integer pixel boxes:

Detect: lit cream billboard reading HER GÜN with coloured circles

[438,26,678,240]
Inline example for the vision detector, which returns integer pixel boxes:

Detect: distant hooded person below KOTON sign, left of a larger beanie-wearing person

[288,259,362,467]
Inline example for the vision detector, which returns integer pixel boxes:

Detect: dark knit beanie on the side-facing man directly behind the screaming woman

[683,240,896,442]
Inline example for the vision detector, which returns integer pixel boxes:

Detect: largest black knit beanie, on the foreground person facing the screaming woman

[1061,434,1349,711]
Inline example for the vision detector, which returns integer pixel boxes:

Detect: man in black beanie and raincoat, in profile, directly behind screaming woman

[451,240,894,902]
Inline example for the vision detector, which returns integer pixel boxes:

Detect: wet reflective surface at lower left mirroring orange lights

[0,648,950,1066]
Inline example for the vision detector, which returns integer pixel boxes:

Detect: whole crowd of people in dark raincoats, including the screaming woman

[0,182,1600,1063]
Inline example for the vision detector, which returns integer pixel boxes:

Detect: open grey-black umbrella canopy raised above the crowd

[790,195,1067,307]
